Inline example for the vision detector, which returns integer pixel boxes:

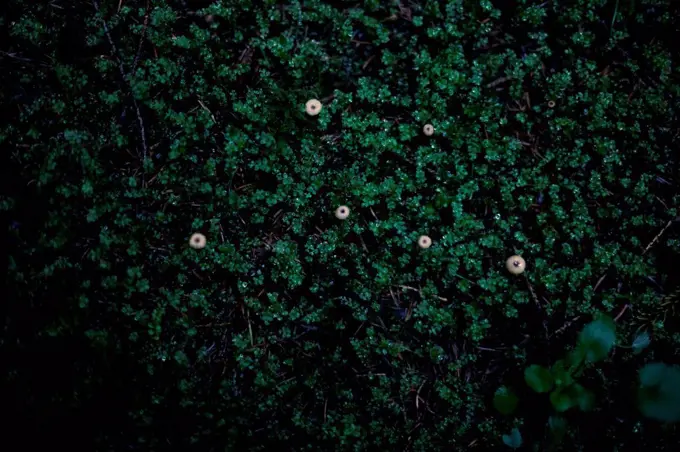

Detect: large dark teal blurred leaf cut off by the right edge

[637,363,680,422]
